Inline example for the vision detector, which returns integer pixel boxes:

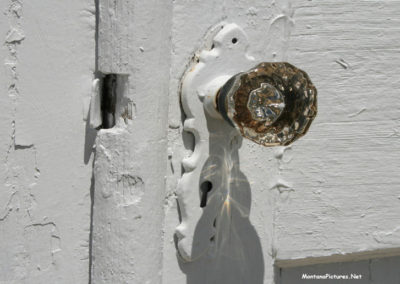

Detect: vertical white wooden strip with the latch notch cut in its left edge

[91,0,172,283]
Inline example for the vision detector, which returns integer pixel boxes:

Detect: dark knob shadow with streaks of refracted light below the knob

[178,114,264,284]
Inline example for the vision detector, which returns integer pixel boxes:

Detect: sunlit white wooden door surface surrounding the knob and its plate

[163,1,400,283]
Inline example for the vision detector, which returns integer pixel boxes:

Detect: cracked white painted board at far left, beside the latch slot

[0,0,95,283]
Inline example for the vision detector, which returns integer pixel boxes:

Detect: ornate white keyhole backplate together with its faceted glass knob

[176,24,317,261]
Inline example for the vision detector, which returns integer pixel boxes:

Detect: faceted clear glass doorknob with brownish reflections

[217,62,317,146]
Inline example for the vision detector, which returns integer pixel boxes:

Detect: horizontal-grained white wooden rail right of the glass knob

[274,1,400,264]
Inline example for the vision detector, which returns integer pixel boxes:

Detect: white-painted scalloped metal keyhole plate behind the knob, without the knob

[176,23,254,261]
